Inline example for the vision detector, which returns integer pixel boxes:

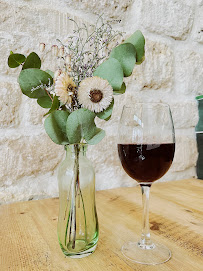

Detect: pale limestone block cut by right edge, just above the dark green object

[175,50,203,95]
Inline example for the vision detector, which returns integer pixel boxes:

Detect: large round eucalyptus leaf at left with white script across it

[18,69,53,99]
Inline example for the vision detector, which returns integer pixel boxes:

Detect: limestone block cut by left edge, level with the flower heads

[0,81,22,127]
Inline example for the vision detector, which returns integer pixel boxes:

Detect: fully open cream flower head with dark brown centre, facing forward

[78,76,113,113]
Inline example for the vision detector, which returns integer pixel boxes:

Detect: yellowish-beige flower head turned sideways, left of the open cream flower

[55,72,76,105]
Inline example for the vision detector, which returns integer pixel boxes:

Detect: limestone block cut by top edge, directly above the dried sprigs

[65,0,133,19]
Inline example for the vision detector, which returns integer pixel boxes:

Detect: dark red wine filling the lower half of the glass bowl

[118,143,175,183]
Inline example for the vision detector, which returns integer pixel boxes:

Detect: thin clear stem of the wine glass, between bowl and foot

[138,184,153,249]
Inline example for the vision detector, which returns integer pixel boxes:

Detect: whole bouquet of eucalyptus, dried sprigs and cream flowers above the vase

[8,17,145,145]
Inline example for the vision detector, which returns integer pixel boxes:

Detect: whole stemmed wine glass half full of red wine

[118,103,175,265]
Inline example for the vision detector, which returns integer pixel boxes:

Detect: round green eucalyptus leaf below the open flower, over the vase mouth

[66,108,105,144]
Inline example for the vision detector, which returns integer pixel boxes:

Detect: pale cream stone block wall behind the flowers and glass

[0,0,203,203]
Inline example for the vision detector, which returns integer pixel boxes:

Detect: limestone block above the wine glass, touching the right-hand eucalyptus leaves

[130,40,173,89]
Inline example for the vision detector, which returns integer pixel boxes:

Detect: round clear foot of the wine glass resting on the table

[121,242,171,265]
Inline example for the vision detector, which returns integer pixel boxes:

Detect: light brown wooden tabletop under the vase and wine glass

[0,179,203,271]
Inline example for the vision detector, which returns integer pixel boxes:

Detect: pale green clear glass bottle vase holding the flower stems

[57,144,99,258]
